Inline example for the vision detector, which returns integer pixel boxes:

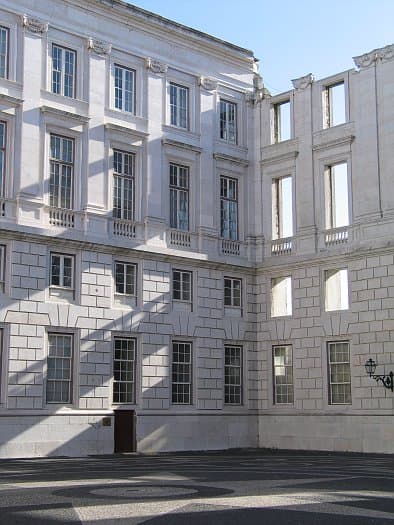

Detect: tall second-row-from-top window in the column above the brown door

[113,150,135,221]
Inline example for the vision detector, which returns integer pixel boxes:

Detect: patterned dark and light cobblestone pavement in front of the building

[0,450,394,525]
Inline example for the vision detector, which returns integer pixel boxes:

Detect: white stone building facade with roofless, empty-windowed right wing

[0,0,394,457]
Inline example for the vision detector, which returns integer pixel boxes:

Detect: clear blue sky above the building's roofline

[129,0,394,94]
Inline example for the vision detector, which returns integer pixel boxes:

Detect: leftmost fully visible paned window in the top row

[52,44,76,98]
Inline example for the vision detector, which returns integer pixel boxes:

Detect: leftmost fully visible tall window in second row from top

[49,134,74,210]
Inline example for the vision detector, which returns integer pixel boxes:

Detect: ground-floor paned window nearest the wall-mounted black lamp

[328,341,352,405]
